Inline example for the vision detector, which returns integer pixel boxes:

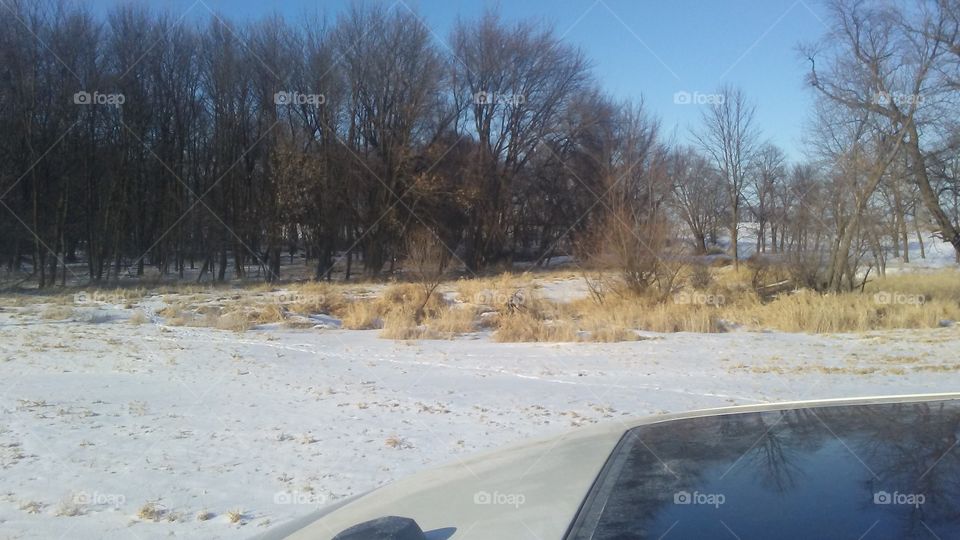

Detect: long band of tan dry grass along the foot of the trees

[16,264,960,342]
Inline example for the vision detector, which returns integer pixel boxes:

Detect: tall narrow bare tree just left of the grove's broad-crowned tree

[336,6,442,275]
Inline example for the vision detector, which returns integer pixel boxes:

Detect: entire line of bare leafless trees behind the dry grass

[0,0,960,288]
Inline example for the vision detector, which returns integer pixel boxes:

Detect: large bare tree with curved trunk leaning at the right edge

[805,0,960,260]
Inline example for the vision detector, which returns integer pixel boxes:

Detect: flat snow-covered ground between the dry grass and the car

[0,306,960,539]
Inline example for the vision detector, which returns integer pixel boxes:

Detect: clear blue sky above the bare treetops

[87,0,824,159]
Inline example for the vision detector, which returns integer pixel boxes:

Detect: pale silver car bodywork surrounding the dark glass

[257,394,960,540]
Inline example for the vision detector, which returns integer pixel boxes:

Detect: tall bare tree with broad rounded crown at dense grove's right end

[450,12,588,268]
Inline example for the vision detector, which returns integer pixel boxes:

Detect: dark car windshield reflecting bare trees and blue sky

[568,400,960,540]
